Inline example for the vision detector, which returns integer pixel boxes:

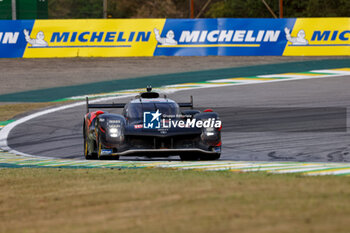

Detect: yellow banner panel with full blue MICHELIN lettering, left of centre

[21,19,165,57]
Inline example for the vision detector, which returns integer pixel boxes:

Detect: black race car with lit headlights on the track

[83,87,222,160]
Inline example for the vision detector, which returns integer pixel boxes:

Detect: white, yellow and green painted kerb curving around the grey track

[0,65,350,175]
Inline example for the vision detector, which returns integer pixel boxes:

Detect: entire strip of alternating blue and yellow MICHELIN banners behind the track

[0,18,350,58]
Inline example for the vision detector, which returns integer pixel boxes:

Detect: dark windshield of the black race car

[128,102,180,121]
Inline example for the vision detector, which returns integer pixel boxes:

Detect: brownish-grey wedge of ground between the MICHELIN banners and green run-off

[0,56,340,94]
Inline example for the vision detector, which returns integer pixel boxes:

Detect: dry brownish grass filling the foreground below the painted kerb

[0,168,350,233]
